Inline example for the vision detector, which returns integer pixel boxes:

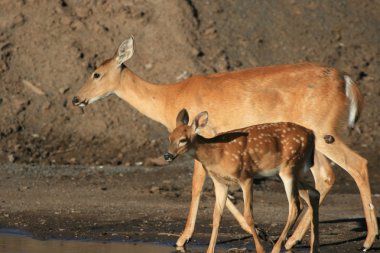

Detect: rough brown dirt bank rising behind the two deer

[0,0,380,168]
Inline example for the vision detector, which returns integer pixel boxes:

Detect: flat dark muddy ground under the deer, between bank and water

[0,159,380,252]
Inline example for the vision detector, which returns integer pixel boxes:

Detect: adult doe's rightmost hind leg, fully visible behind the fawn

[316,136,379,251]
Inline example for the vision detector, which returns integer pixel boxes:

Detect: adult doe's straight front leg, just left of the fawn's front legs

[176,160,207,247]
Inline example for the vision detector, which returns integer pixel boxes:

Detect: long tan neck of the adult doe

[115,69,173,127]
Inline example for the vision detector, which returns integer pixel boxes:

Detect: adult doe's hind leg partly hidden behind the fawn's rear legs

[285,152,335,249]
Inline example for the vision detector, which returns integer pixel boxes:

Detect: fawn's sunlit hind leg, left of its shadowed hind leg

[272,168,301,253]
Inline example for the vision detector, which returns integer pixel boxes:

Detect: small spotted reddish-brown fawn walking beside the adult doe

[164,109,319,253]
